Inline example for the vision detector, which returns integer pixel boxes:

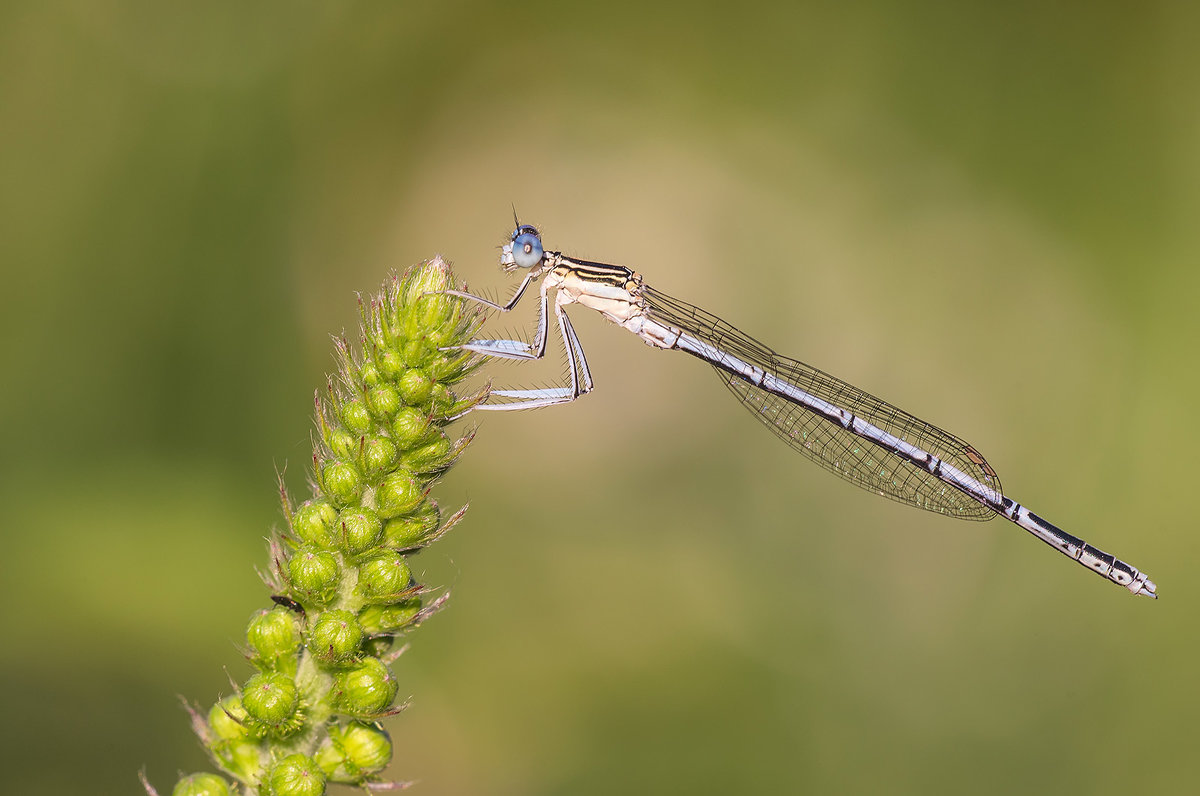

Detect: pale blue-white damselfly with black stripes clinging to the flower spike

[450,222,1157,598]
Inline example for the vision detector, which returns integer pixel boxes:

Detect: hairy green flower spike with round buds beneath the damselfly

[142,258,486,796]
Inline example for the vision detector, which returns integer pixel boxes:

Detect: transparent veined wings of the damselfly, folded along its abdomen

[642,286,1003,520]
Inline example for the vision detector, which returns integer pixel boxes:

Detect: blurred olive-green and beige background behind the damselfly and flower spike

[0,0,1200,796]
